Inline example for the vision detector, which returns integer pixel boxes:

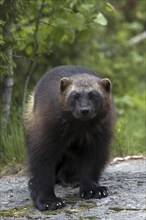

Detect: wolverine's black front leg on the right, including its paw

[79,152,108,199]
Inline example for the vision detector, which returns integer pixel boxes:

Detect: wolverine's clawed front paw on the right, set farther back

[79,186,109,199]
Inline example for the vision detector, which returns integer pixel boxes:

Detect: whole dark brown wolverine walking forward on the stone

[25,66,114,210]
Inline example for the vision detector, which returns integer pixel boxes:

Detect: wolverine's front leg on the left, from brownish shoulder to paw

[26,117,65,211]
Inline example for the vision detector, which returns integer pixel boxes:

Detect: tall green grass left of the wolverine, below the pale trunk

[0,109,25,168]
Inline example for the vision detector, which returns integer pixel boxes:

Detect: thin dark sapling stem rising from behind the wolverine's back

[22,0,45,110]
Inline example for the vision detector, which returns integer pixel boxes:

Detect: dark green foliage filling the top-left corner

[0,0,26,76]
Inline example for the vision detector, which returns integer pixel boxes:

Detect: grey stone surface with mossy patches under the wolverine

[0,160,146,220]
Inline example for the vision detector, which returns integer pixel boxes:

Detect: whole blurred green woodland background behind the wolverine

[0,0,146,167]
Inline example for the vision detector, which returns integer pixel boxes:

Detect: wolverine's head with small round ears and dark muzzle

[60,74,111,121]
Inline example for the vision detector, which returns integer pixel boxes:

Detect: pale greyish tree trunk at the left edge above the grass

[2,49,14,126]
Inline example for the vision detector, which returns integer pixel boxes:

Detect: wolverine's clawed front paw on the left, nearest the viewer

[34,197,66,211]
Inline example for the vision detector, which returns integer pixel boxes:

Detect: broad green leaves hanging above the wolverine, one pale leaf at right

[14,0,110,57]
